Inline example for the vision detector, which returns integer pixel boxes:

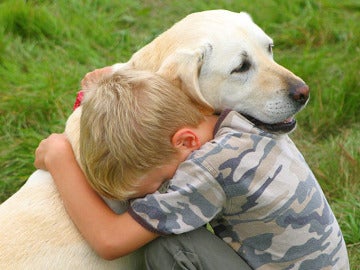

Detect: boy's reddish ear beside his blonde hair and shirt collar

[171,128,201,150]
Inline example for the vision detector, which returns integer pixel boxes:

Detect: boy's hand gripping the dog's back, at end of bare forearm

[34,133,74,171]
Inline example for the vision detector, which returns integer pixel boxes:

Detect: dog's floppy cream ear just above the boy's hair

[156,45,214,115]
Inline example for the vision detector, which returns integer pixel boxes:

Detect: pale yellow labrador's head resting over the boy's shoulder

[128,10,309,133]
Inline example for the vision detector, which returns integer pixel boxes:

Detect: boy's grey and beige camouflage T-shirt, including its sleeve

[129,112,349,270]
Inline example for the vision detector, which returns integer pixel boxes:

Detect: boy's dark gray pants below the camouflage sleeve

[145,228,251,270]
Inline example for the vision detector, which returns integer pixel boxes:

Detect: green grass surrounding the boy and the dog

[0,0,360,269]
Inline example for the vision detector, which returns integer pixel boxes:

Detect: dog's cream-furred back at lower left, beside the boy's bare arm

[0,170,143,269]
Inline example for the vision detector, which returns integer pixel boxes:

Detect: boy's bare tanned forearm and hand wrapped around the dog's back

[35,134,158,259]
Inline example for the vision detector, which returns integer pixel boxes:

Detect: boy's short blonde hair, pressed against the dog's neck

[80,69,204,200]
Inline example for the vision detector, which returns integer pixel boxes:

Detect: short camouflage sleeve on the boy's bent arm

[129,160,225,234]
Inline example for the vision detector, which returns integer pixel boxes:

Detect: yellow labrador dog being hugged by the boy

[0,10,309,269]
